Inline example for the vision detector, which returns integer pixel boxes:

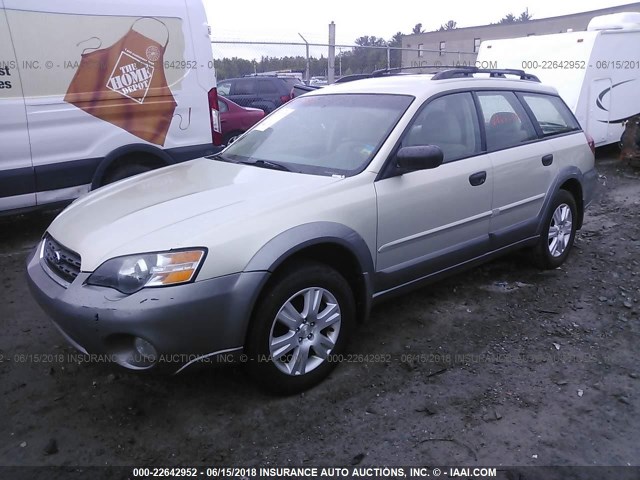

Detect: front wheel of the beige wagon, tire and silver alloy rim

[246,262,355,395]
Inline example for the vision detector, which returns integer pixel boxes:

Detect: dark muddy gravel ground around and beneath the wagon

[0,151,640,478]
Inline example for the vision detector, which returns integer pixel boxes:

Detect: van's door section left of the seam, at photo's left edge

[0,0,36,211]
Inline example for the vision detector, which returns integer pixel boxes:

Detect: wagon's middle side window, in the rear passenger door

[478,92,538,150]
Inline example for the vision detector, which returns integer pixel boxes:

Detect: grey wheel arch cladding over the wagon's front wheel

[245,222,374,321]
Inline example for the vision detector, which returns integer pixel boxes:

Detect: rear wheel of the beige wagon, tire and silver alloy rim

[533,190,578,269]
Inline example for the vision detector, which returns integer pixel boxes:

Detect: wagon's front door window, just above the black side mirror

[402,93,481,162]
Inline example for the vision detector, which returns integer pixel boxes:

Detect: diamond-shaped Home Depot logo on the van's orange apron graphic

[107,50,154,103]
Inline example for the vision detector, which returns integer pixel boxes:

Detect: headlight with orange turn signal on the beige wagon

[87,249,206,294]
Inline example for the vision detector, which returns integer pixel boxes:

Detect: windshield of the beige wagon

[223,94,414,176]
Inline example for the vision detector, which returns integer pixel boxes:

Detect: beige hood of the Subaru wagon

[48,158,340,271]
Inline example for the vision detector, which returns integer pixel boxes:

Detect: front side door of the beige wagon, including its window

[375,93,493,292]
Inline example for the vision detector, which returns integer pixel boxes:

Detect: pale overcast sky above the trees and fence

[203,0,632,58]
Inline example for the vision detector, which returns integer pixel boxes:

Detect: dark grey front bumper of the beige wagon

[27,249,269,371]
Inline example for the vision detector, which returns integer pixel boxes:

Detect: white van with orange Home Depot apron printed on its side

[0,0,222,213]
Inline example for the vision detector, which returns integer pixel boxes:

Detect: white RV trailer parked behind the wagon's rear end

[478,13,640,146]
